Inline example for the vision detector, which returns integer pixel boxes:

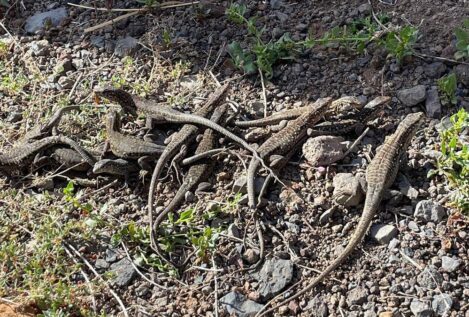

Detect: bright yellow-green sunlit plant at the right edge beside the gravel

[428,108,469,214]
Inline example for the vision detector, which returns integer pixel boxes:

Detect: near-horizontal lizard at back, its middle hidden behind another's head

[234,96,361,128]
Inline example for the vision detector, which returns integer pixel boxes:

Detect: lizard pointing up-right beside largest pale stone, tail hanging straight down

[247,98,331,209]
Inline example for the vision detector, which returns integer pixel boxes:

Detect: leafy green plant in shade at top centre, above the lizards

[226,3,303,78]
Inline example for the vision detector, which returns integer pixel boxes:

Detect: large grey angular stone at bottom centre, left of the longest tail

[254,259,293,299]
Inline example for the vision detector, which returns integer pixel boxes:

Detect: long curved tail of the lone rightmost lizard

[256,191,379,317]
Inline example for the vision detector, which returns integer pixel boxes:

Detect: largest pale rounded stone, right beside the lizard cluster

[303,135,347,166]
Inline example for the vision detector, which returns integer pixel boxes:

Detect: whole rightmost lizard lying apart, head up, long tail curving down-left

[256,112,424,317]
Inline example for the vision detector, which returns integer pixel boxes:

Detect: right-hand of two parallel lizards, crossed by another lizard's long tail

[152,105,228,265]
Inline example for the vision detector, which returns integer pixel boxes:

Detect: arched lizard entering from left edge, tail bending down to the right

[0,135,95,170]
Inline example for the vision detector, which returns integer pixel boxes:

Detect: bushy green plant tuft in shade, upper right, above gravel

[381,26,418,62]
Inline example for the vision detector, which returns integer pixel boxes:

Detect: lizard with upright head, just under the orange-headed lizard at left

[106,110,165,159]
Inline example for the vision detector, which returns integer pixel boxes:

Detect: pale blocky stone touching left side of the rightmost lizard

[332,173,364,206]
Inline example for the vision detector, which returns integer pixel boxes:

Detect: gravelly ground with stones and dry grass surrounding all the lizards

[0,0,469,317]
